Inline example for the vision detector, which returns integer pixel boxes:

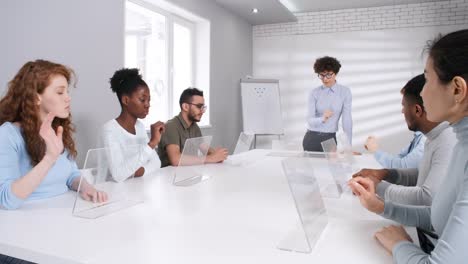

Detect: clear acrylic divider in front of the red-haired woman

[72,146,143,219]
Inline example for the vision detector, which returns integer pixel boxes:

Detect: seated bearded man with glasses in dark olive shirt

[158,88,228,167]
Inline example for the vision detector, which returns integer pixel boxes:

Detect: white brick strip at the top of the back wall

[253,0,468,38]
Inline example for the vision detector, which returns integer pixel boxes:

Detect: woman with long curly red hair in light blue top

[0,60,107,210]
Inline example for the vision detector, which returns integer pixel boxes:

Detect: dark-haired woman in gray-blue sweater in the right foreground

[349,30,468,264]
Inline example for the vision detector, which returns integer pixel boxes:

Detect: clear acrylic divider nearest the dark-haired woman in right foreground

[278,158,328,253]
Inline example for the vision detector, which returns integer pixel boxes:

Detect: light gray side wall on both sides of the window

[0,0,252,165]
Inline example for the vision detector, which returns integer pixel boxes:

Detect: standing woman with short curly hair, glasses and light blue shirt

[302,56,353,151]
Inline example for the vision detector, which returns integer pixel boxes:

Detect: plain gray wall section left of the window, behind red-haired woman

[0,0,124,164]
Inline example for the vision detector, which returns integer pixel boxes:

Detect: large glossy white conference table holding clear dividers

[0,150,415,264]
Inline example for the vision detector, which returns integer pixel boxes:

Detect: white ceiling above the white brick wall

[215,0,446,25]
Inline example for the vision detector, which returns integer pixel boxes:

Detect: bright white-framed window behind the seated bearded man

[125,1,209,129]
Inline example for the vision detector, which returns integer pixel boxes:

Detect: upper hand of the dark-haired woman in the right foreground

[348,177,384,214]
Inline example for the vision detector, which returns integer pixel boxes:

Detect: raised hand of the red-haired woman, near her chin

[39,113,63,162]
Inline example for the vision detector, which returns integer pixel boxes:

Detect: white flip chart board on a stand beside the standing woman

[241,79,283,135]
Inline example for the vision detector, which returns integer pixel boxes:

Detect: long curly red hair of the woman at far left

[0,60,77,166]
